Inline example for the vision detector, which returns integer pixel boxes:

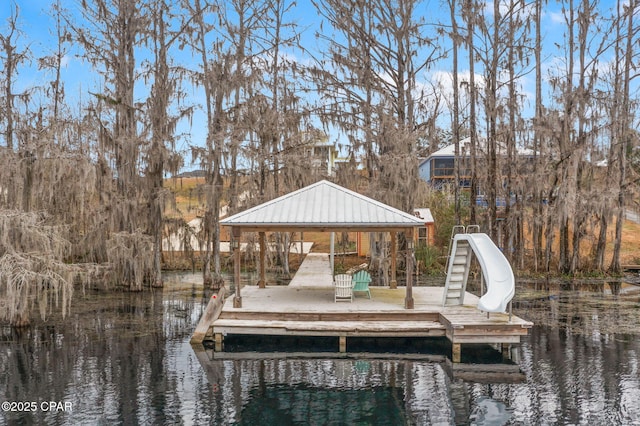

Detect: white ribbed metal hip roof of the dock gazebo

[220,180,424,231]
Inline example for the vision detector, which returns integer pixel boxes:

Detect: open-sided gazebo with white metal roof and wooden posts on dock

[220,180,424,309]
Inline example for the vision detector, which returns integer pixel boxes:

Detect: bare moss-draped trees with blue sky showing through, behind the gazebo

[0,0,640,326]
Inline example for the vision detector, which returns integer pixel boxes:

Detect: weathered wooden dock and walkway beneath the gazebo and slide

[194,254,533,362]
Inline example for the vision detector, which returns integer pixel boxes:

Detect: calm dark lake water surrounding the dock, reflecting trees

[0,274,640,425]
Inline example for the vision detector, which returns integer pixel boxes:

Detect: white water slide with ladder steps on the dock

[443,233,515,312]
